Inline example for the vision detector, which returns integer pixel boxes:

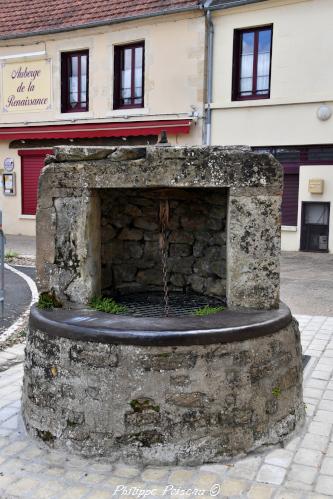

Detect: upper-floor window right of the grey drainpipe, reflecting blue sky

[232,26,273,100]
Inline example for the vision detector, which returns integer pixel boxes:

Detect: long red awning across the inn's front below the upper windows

[0,119,191,140]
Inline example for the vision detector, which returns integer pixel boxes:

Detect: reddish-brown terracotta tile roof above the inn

[0,0,201,38]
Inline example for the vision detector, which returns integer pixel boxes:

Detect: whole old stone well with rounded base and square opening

[23,146,304,464]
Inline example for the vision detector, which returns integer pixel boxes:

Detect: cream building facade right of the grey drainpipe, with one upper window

[207,0,333,253]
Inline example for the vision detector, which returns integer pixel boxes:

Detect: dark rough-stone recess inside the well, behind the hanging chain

[100,188,227,298]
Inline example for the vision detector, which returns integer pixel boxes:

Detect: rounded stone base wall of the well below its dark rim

[23,309,304,465]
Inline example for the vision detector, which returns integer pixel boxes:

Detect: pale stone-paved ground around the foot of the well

[0,316,333,499]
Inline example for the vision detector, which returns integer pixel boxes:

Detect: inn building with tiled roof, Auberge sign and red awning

[0,0,205,235]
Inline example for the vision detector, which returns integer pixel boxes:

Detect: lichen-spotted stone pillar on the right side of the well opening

[227,188,281,310]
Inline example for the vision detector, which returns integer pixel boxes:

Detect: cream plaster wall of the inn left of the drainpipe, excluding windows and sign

[0,12,205,235]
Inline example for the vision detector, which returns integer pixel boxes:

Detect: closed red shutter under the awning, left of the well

[18,150,52,215]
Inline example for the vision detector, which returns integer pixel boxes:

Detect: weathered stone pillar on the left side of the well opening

[37,189,101,304]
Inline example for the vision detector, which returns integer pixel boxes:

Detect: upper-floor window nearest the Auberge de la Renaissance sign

[61,50,89,113]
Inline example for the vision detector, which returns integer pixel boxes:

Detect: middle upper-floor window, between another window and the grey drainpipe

[113,42,144,109]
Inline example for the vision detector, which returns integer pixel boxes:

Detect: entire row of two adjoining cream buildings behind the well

[0,0,333,252]
